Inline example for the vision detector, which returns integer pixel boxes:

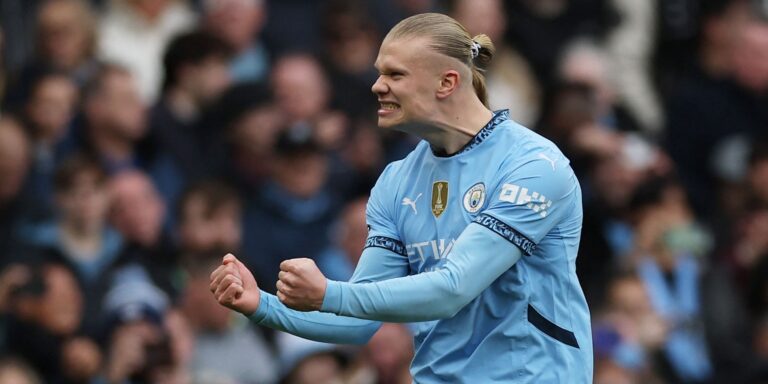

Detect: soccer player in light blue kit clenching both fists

[211,14,592,383]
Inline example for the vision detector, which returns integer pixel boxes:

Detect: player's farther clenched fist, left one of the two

[210,253,261,316]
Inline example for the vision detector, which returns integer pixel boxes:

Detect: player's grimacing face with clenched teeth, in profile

[371,37,440,128]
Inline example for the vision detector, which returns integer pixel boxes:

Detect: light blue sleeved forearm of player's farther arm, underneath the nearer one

[249,291,381,344]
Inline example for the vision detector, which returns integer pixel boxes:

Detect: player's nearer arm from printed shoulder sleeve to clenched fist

[278,152,581,322]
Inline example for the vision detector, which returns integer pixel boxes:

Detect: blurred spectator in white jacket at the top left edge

[98,0,196,104]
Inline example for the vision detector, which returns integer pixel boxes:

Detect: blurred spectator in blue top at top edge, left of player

[203,0,269,83]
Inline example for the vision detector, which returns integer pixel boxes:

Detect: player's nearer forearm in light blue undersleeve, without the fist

[321,225,521,322]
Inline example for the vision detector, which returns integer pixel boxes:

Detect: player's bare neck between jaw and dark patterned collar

[410,94,493,155]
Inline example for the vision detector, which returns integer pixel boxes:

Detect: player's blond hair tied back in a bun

[387,13,496,107]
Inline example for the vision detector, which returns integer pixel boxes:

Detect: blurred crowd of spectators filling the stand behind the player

[0,0,768,384]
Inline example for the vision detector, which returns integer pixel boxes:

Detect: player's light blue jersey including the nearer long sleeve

[249,111,592,383]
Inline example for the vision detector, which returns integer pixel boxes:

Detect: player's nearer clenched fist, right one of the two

[277,259,328,311]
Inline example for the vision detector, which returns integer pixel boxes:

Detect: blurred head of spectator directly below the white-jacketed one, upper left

[82,64,149,174]
